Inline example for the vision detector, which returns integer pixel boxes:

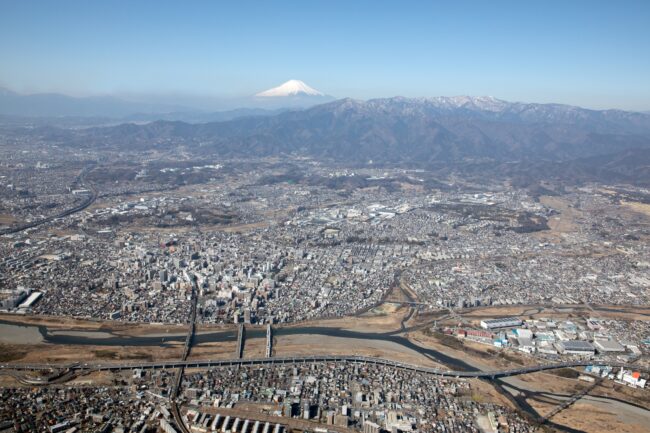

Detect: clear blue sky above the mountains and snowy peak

[0,0,650,110]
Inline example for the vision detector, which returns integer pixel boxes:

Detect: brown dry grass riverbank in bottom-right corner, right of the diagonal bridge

[553,401,650,433]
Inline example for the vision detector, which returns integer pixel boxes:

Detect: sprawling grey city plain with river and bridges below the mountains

[0,132,650,433]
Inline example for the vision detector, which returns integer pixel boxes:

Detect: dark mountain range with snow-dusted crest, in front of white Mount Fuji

[12,96,650,167]
